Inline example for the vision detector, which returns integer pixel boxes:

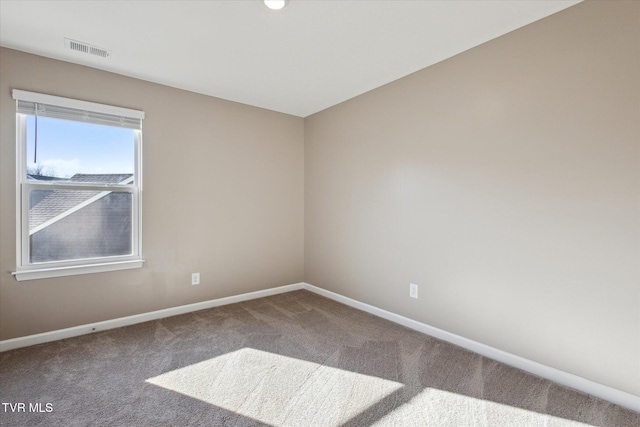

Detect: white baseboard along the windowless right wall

[303,283,640,412]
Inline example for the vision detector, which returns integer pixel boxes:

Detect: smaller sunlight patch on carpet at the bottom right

[373,388,590,427]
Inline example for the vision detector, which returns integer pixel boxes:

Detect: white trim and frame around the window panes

[11,89,144,281]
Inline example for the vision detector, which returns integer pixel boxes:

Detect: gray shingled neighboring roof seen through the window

[29,173,133,234]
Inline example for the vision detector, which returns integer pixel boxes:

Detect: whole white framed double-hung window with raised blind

[12,89,144,281]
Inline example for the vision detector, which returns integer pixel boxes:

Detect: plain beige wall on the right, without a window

[305,2,640,396]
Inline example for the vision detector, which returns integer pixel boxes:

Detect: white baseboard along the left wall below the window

[0,283,305,352]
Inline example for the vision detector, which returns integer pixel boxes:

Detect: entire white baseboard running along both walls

[0,282,640,412]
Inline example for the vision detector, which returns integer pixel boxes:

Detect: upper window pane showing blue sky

[26,116,136,184]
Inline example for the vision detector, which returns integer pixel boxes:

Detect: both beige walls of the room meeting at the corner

[0,2,640,402]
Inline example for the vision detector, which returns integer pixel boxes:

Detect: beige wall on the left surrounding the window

[0,49,304,340]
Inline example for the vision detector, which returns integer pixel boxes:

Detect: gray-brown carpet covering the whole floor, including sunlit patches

[0,291,640,427]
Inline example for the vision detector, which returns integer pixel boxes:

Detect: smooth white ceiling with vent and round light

[0,0,579,117]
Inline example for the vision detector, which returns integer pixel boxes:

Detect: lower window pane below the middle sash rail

[29,190,133,264]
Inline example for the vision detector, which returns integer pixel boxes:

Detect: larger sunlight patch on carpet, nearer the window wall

[147,348,403,426]
